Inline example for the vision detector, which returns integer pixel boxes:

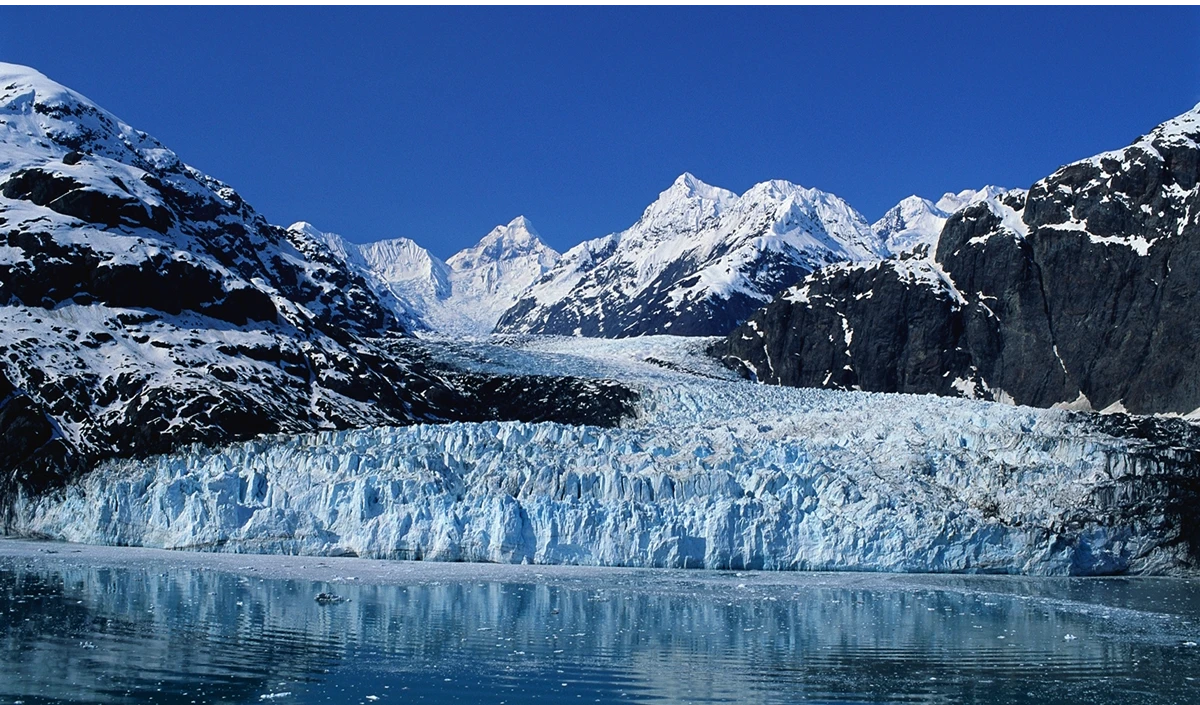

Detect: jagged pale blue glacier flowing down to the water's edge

[14,337,1187,574]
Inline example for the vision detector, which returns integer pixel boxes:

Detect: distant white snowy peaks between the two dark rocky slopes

[297,169,1006,337]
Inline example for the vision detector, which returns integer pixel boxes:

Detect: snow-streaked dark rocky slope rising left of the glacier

[0,64,638,500]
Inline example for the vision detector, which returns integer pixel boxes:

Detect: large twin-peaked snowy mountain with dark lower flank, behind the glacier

[497,174,886,337]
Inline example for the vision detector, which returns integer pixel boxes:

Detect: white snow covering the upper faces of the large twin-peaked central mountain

[496,174,883,332]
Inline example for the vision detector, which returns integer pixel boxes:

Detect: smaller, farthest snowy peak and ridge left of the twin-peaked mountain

[289,216,559,336]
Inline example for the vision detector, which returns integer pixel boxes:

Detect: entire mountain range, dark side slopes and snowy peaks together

[0,57,1200,508]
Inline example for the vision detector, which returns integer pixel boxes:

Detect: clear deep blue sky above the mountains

[0,6,1200,258]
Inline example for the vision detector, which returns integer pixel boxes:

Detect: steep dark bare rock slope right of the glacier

[714,103,1200,415]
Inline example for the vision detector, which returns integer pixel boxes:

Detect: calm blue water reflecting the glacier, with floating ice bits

[0,541,1200,705]
